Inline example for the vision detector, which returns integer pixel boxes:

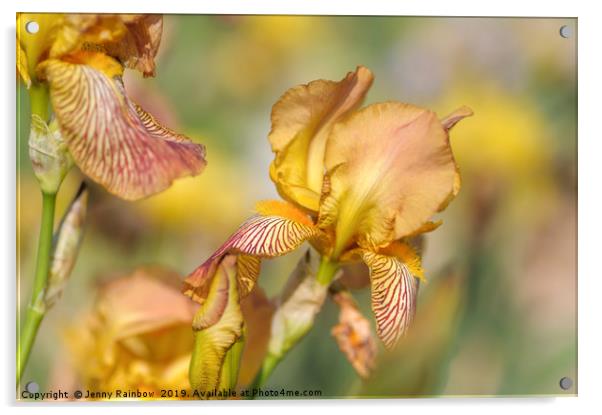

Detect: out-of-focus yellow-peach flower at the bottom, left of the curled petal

[66,268,196,398]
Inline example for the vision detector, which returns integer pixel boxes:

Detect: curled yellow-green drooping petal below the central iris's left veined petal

[190,256,243,397]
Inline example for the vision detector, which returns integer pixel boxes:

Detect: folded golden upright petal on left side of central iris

[268,66,373,212]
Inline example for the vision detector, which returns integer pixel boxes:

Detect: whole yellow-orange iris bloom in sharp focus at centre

[184,66,472,390]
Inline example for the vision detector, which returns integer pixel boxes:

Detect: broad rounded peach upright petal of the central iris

[318,102,456,257]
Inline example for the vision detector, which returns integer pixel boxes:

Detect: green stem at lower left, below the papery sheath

[17,193,56,386]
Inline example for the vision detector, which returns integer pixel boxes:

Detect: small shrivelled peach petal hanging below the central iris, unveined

[331,291,377,378]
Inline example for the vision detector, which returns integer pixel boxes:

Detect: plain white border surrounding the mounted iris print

[0,0,602,415]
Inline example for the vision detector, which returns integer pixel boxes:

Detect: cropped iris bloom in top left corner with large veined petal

[17,14,206,200]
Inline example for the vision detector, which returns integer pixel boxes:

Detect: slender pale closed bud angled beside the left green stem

[44,185,88,308]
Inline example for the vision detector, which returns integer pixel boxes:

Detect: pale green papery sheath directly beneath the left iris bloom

[29,114,73,194]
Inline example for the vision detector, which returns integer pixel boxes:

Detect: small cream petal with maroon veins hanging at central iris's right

[363,250,418,348]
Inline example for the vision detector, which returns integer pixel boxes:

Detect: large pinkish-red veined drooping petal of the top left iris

[40,53,206,200]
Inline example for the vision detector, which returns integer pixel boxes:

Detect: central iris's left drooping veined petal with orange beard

[184,201,319,303]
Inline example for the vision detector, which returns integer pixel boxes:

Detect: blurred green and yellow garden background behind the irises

[18,15,577,397]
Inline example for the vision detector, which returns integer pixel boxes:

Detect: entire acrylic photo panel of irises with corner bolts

[16,14,577,402]
